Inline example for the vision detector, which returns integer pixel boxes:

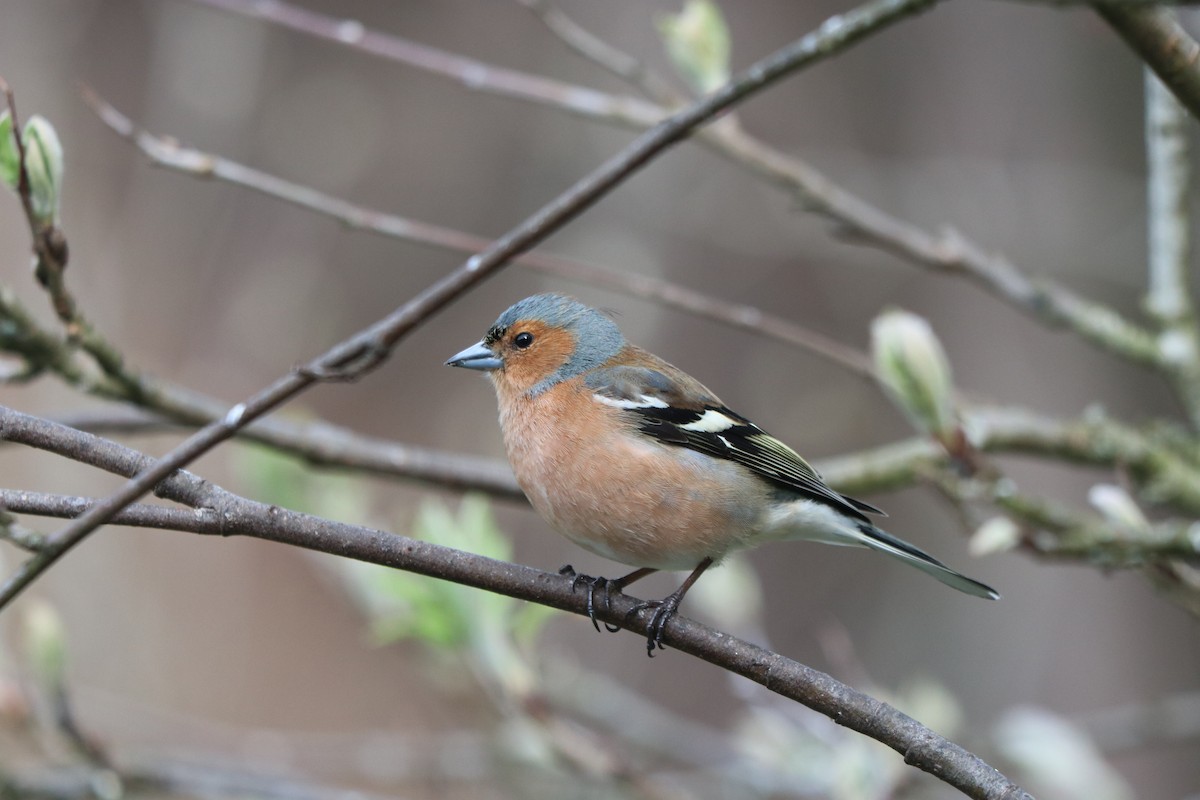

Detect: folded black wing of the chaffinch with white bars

[586,362,882,522]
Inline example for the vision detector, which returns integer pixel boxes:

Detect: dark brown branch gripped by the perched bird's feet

[0,407,1030,800]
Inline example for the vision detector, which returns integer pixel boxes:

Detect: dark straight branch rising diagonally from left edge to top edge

[0,0,937,609]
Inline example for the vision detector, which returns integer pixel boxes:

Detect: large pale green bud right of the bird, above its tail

[871,309,958,439]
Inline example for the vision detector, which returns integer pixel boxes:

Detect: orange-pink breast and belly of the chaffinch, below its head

[500,384,766,570]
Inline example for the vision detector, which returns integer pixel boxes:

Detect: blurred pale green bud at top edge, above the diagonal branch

[659,0,730,94]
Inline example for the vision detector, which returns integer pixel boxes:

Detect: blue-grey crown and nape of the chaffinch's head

[492,294,625,396]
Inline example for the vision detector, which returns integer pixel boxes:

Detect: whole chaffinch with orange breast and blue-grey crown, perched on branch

[446,294,1000,655]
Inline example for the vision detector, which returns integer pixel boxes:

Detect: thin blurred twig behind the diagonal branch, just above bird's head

[83,86,874,378]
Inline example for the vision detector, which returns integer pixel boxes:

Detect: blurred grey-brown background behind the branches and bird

[0,0,1200,798]
